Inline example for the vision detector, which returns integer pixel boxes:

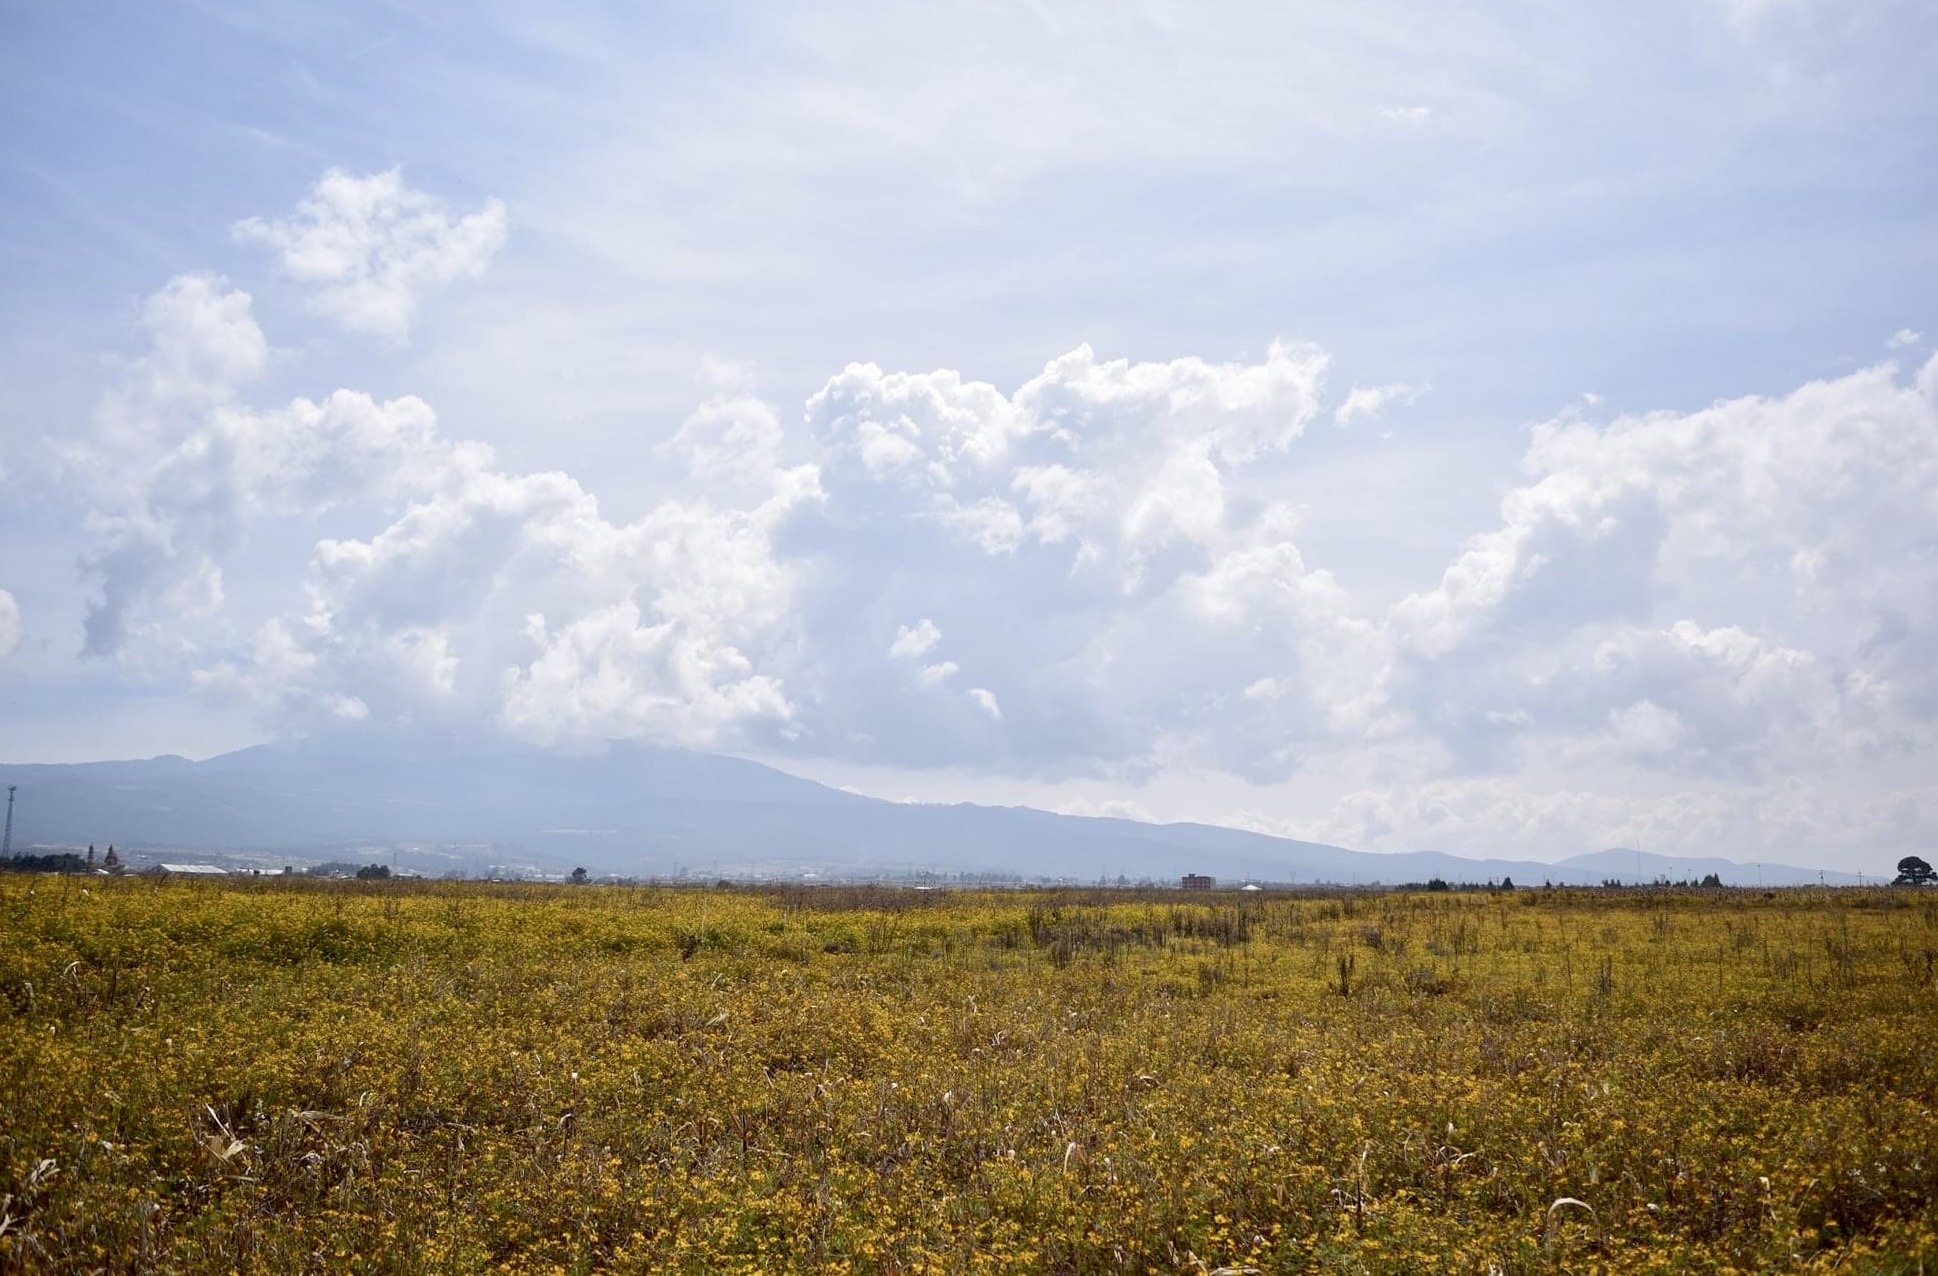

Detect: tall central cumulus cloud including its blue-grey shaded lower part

[802,333,1382,774]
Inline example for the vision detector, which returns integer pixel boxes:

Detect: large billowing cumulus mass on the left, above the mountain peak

[66,277,818,743]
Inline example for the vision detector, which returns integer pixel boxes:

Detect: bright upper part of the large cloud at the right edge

[1395,356,1938,650]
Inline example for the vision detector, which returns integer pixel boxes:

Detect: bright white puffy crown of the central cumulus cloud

[808,343,1328,578]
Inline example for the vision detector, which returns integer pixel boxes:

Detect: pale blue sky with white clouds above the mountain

[0,0,1938,871]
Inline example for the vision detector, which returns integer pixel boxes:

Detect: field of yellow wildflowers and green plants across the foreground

[0,877,1938,1272]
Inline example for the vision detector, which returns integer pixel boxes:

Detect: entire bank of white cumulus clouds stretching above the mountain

[56,173,1938,864]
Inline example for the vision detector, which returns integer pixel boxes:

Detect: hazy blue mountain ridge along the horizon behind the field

[0,745,1851,884]
